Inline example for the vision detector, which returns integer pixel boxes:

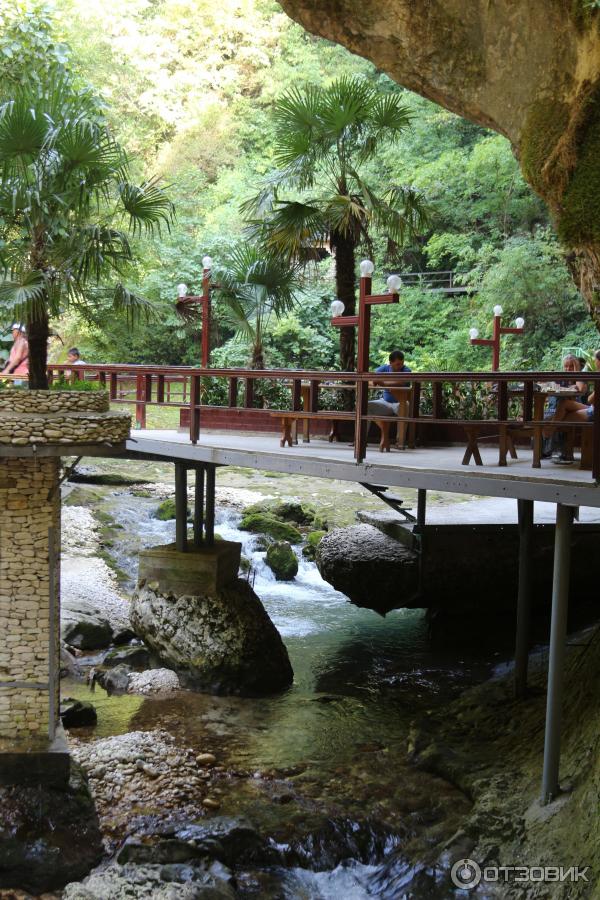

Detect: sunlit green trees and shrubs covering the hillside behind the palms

[0,0,598,384]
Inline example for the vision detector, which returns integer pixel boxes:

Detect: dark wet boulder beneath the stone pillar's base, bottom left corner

[0,761,103,896]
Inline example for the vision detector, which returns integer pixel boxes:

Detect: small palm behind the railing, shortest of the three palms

[213,243,300,369]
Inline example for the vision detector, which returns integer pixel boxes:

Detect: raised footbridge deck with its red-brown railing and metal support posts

[34,366,600,804]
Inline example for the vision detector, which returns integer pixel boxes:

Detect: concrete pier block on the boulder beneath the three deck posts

[138,541,242,596]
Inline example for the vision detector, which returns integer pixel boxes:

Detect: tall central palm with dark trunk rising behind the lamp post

[242,78,426,371]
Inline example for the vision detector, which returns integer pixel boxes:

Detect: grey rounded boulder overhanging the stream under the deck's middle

[316,525,420,615]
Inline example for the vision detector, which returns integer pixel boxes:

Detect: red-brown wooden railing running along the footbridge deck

[48,364,600,482]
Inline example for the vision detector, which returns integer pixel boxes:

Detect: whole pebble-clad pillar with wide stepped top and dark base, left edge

[0,389,131,783]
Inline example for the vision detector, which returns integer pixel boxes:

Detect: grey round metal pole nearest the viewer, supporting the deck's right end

[541,503,573,804]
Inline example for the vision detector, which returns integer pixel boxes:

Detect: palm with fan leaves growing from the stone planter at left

[0,72,173,389]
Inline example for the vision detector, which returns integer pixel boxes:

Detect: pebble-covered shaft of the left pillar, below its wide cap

[0,458,60,749]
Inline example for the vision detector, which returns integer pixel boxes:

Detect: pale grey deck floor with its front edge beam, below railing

[127,430,600,507]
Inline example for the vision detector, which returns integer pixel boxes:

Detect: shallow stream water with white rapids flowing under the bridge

[68,492,511,900]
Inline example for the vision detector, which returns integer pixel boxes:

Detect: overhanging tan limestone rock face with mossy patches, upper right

[281,0,600,327]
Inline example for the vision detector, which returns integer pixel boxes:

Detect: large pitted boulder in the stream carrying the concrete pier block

[131,579,293,696]
